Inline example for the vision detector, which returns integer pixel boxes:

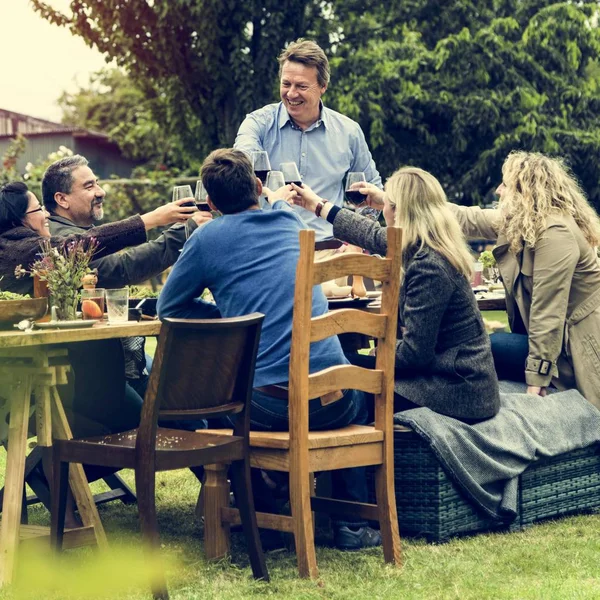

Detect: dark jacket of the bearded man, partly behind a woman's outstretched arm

[50,215,196,288]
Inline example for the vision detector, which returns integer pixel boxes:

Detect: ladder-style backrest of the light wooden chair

[289,227,402,438]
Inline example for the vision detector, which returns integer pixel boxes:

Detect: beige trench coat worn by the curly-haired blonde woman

[450,204,600,408]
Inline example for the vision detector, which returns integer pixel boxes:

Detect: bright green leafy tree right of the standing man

[332,1,600,208]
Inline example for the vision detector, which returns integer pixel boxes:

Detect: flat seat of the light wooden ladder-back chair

[198,425,383,450]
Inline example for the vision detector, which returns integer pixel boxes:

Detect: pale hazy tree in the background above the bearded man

[58,68,188,167]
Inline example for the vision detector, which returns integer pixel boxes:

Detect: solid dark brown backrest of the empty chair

[140,313,264,440]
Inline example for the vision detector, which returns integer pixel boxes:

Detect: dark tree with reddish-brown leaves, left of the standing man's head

[33,0,327,153]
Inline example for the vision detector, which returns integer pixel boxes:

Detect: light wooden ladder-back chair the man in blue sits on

[204,227,402,578]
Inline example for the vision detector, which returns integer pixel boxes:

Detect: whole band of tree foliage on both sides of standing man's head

[33,0,600,211]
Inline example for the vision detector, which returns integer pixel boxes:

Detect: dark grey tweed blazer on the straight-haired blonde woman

[333,209,500,419]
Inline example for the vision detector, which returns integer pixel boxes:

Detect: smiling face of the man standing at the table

[279,60,327,129]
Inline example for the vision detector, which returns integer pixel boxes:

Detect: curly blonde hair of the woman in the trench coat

[499,152,600,253]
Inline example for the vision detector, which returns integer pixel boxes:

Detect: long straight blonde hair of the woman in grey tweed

[385,167,473,279]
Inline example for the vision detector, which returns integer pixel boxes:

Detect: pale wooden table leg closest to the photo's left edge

[0,373,34,586]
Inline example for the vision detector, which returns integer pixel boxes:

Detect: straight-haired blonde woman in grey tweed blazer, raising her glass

[294,167,500,420]
